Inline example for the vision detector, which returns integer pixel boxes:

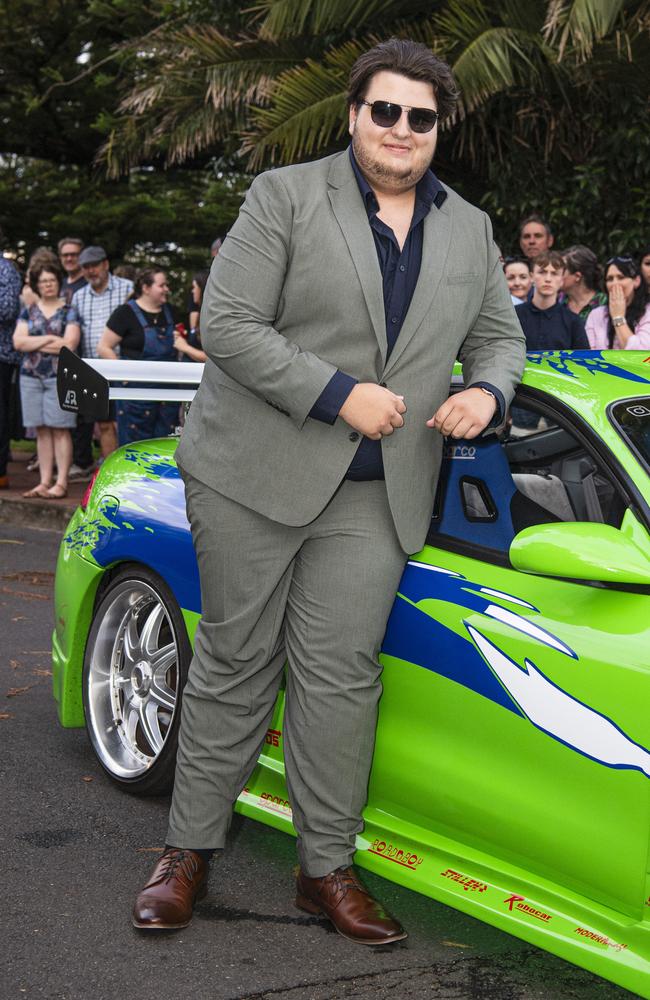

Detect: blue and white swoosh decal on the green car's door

[382,561,650,777]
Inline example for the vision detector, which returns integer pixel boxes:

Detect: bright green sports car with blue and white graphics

[53,351,650,997]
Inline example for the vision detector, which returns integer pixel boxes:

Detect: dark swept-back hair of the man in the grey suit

[348,38,459,121]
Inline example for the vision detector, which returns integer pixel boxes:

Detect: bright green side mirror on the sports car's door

[510,510,650,584]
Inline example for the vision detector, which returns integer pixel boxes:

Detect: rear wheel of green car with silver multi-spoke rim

[83,564,192,795]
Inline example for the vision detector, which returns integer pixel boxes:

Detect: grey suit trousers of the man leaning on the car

[167,472,406,877]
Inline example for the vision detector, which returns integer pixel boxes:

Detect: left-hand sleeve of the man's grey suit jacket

[201,171,337,427]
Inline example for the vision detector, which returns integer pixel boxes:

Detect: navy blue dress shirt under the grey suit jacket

[309,146,505,480]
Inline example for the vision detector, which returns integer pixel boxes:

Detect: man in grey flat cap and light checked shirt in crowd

[69,246,133,472]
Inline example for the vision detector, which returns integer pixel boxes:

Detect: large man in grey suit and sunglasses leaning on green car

[133,39,525,945]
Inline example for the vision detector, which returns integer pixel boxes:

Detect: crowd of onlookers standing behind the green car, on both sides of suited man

[0,215,650,499]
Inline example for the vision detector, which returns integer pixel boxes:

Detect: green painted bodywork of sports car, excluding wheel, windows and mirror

[54,352,650,996]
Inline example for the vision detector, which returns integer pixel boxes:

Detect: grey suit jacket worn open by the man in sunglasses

[177,152,525,552]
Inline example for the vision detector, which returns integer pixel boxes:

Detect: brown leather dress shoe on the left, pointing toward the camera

[133,849,208,931]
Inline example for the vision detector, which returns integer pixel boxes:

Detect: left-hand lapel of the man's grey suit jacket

[328,153,388,364]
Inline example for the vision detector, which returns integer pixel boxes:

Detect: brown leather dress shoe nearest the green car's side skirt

[296,868,407,944]
